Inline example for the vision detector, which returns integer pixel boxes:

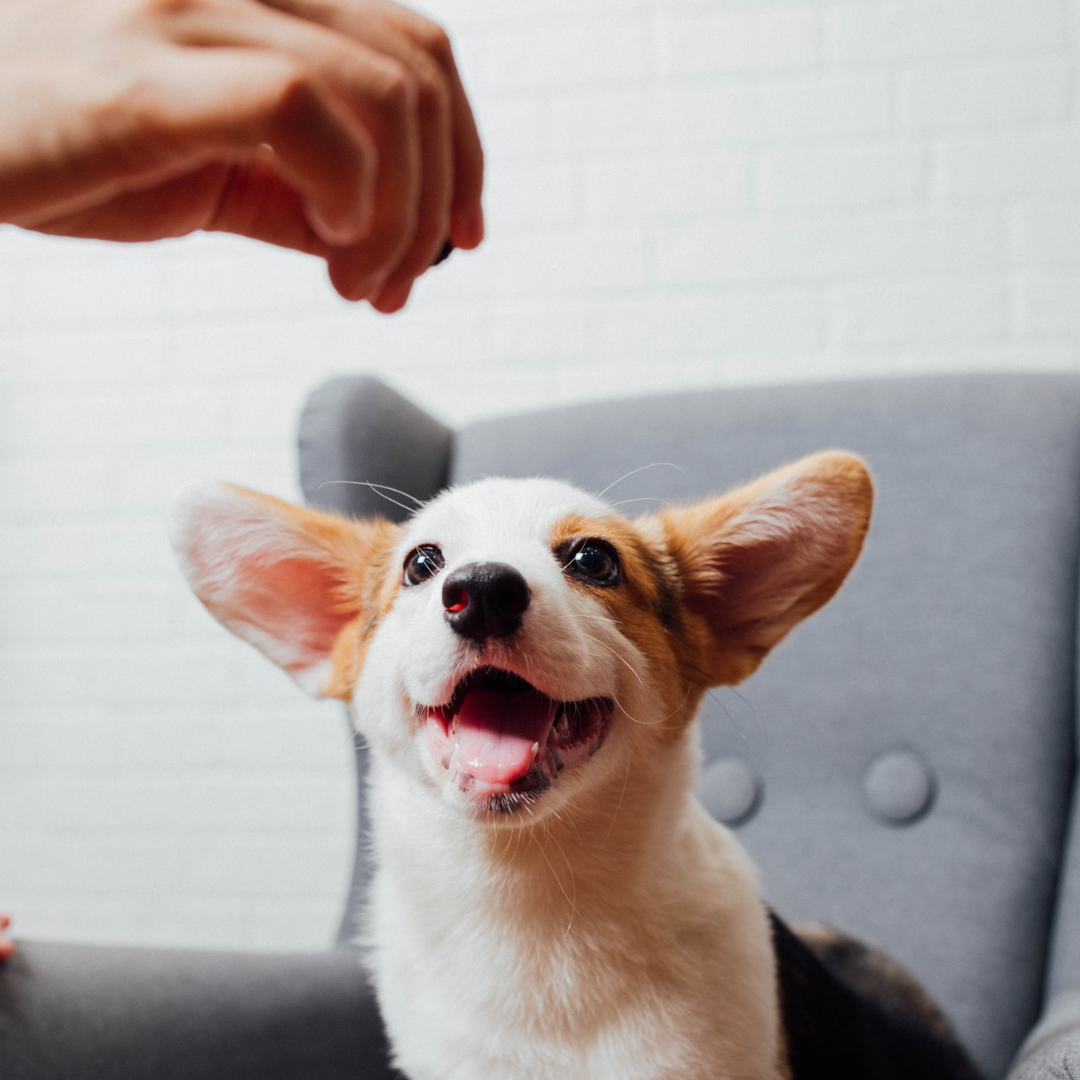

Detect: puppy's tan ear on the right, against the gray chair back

[658,451,874,685]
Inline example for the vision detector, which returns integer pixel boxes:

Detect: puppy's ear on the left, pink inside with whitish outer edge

[168,484,399,698]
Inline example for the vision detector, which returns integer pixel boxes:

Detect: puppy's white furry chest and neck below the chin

[370,760,780,1080]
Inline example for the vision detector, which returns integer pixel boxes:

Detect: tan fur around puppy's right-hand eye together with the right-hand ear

[550,453,874,738]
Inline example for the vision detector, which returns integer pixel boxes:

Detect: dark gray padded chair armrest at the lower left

[0,942,397,1080]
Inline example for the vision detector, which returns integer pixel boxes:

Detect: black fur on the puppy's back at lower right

[769,912,983,1080]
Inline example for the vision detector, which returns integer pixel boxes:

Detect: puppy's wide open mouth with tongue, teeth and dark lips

[421,667,615,809]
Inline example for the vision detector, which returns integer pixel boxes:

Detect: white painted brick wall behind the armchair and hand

[0,0,1080,948]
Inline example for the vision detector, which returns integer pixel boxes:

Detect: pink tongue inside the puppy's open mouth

[451,690,558,784]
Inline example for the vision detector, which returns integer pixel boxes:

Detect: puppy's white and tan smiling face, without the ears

[354,480,678,816]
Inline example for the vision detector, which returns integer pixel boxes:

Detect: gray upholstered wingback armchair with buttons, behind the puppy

[6,376,1080,1080]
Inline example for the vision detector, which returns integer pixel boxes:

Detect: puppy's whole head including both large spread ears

[173,454,872,822]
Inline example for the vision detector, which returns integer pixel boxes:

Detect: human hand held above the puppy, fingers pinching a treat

[0,0,484,311]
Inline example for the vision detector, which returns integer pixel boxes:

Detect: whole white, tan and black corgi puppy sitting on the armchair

[171,453,989,1080]
